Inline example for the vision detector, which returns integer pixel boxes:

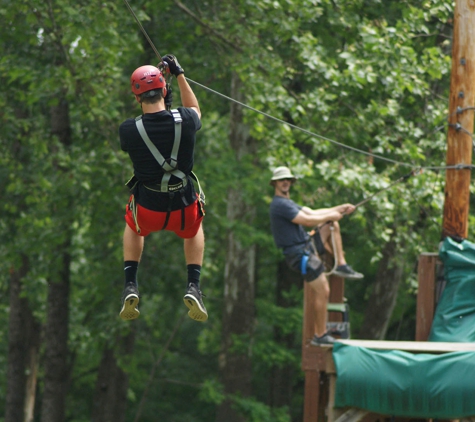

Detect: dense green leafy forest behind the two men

[0,0,473,422]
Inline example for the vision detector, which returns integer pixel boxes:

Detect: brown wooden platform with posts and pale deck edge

[302,252,475,422]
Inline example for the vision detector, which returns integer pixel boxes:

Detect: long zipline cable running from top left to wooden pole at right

[124,0,475,170]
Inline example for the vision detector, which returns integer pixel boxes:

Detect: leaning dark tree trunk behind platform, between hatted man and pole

[359,239,404,340]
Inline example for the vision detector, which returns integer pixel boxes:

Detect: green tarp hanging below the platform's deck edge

[333,342,475,419]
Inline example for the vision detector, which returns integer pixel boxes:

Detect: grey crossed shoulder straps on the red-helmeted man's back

[135,109,186,192]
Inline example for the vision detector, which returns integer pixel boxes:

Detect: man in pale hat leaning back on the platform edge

[269,166,363,345]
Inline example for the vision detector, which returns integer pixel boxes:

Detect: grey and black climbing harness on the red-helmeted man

[126,109,206,233]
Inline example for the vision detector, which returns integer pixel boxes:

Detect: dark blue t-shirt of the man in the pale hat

[269,196,309,255]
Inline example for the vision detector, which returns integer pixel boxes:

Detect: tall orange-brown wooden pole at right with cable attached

[442,0,475,239]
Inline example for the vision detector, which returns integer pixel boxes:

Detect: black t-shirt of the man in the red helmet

[119,107,201,211]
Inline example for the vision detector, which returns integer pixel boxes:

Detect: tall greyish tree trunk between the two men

[216,74,256,422]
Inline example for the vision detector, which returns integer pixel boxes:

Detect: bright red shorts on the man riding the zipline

[125,195,204,239]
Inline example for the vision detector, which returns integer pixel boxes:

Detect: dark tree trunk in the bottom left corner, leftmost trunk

[5,256,40,422]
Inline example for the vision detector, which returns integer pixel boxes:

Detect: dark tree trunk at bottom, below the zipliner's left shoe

[91,330,135,422]
